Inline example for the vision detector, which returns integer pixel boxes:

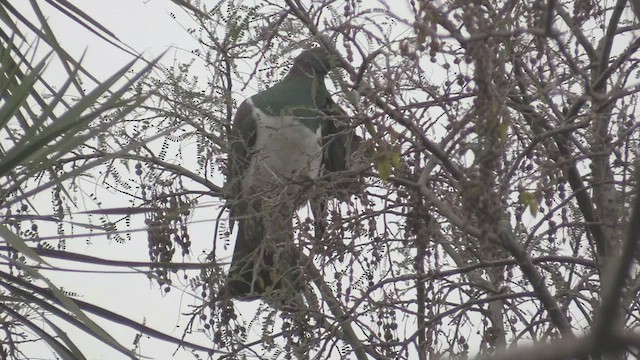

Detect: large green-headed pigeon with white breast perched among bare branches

[226,47,359,300]
